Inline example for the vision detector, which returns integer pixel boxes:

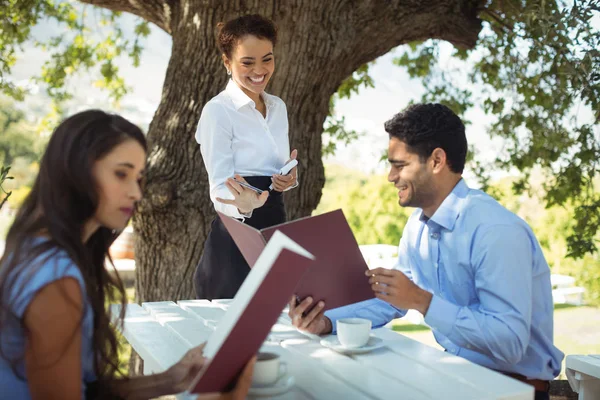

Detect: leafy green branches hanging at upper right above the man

[395,0,600,257]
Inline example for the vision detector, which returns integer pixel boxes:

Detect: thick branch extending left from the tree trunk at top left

[79,0,171,34]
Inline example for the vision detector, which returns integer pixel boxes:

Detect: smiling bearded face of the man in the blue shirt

[388,137,436,208]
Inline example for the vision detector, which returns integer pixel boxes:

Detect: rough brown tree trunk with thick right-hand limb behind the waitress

[123,0,481,301]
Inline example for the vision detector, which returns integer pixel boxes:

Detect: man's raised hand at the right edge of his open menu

[365,268,433,315]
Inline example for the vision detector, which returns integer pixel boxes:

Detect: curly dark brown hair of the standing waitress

[217,14,277,59]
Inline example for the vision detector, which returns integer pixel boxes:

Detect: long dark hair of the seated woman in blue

[0,110,147,396]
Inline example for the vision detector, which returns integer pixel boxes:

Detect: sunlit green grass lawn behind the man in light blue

[392,304,600,379]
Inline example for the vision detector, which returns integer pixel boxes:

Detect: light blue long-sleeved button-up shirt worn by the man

[325,180,564,380]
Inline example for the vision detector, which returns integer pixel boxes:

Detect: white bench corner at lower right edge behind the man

[565,355,600,400]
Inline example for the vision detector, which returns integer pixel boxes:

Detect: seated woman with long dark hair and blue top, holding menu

[0,110,253,400]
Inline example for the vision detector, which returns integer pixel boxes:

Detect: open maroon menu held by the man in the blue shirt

[219,210,374,310]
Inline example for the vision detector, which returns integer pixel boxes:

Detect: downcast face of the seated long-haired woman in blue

[91,139,146,230]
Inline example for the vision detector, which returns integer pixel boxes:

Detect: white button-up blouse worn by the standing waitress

[196,80,290,218]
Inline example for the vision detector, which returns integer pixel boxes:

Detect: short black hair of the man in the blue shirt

[385,104,467,173]
